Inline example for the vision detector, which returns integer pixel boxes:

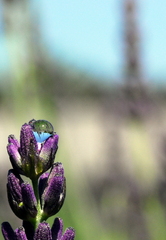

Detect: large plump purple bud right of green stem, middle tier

[41,163,66,219]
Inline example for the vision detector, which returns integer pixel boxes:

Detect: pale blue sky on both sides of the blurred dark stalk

[0,0,166,84]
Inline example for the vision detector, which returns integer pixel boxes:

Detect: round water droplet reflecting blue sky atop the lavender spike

[29,119,54,143]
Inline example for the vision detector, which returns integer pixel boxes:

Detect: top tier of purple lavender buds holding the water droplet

[7,120,59,179]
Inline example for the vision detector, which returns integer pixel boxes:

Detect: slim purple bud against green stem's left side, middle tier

[21,183,37,218]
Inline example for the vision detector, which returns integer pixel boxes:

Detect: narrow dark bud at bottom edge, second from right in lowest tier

[51,218,63,240]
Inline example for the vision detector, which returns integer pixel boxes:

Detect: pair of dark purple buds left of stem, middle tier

[7,170,37,220]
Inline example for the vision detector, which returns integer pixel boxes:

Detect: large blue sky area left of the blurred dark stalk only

[36,0,120,80]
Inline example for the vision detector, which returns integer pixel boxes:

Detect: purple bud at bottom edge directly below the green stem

[34,222,52,240]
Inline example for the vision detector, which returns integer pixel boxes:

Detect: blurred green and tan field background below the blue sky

[0,0,166,240]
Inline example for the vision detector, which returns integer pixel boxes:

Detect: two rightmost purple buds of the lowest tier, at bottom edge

[51,218,75,240]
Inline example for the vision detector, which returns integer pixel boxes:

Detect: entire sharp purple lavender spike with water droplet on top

[2,119,75,240]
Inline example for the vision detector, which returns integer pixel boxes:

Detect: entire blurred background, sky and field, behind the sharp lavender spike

[0,0,166,240]
